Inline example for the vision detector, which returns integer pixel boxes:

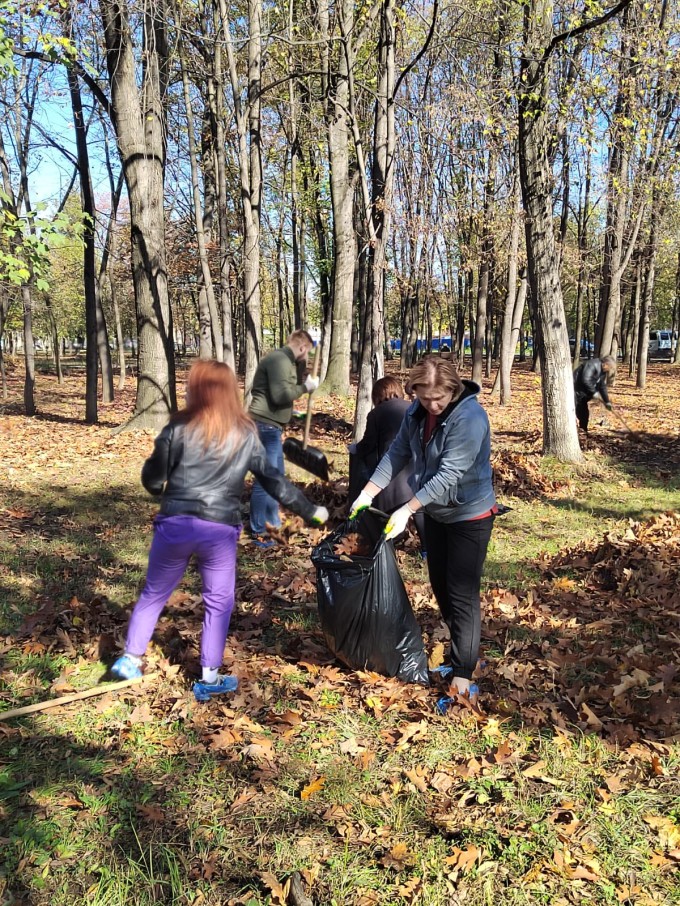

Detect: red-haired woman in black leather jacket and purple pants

[111,360,328,701]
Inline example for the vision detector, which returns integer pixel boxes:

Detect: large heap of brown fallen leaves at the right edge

[487,514,680,746]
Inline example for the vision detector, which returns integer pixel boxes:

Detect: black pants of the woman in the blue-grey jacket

[425,515,494,679]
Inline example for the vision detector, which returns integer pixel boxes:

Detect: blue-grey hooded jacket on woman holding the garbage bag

[371,381,496,522]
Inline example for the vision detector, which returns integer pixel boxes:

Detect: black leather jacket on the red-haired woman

[142,423,316,525]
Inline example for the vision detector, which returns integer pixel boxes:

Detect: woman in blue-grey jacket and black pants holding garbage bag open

[350,356,498,697]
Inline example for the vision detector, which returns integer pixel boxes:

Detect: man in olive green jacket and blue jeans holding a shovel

[248,330,319,549]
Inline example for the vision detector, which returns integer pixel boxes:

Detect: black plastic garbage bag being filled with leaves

[312,509,429,686]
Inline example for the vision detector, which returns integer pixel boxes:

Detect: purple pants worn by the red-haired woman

[125,516,241,667]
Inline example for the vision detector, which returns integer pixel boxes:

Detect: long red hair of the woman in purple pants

[173,359,255,447]
